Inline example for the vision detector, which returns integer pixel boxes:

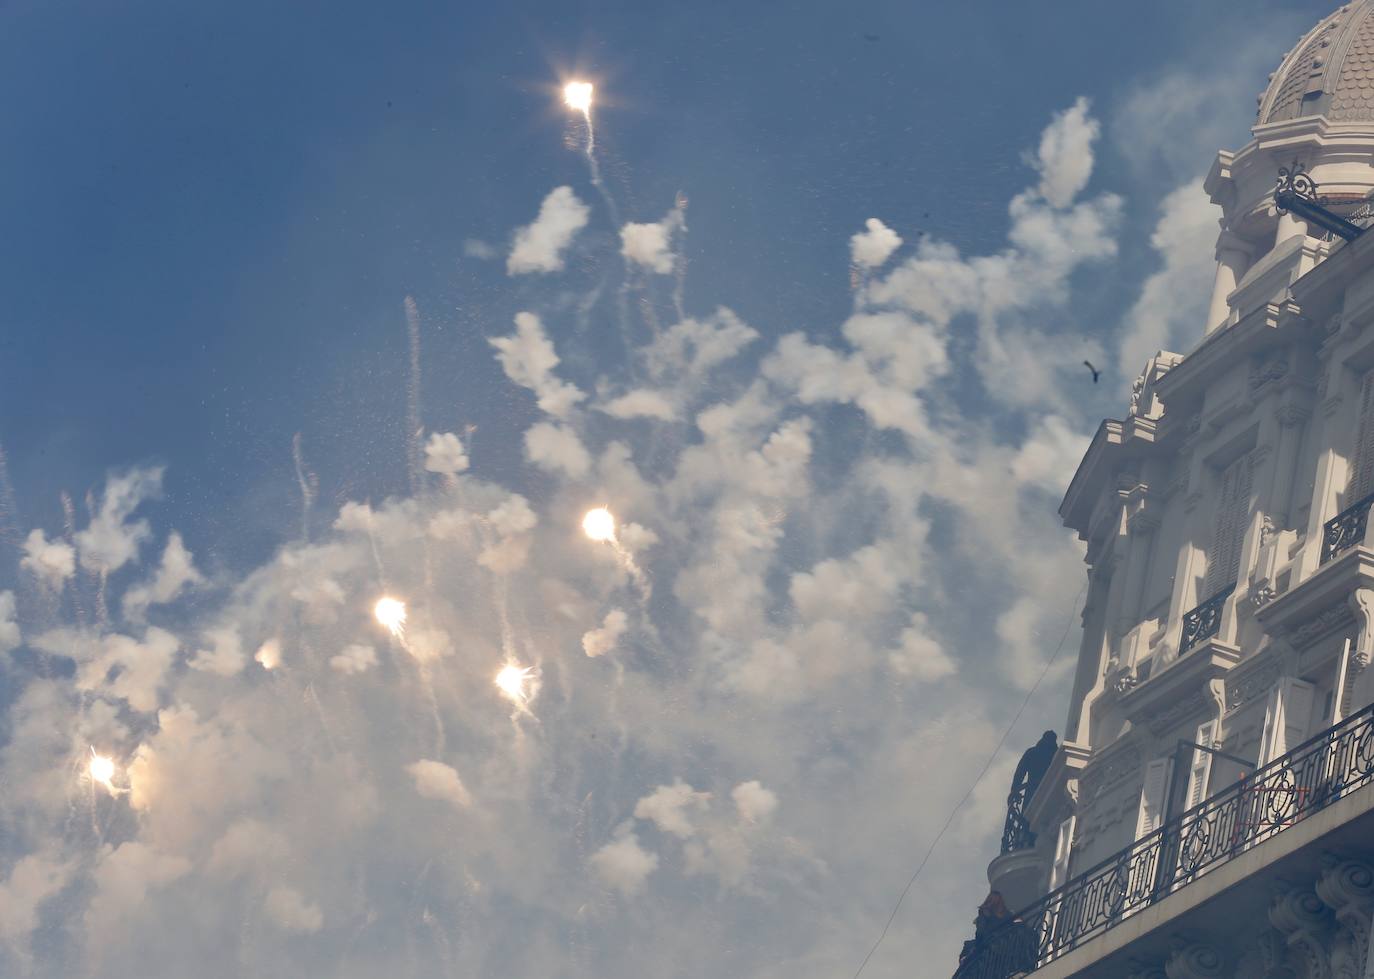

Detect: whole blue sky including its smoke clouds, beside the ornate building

[0,0,1329,976]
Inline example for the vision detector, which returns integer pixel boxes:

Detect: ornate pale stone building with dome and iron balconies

[959,0,1374,979]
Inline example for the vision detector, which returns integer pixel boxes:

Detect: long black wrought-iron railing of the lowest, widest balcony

[955,704,1374,979]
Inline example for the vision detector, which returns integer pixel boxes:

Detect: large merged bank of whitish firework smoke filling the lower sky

[0,97,1170,979]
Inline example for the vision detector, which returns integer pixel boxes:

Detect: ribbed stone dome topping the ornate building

[1257,0,1374,125]
